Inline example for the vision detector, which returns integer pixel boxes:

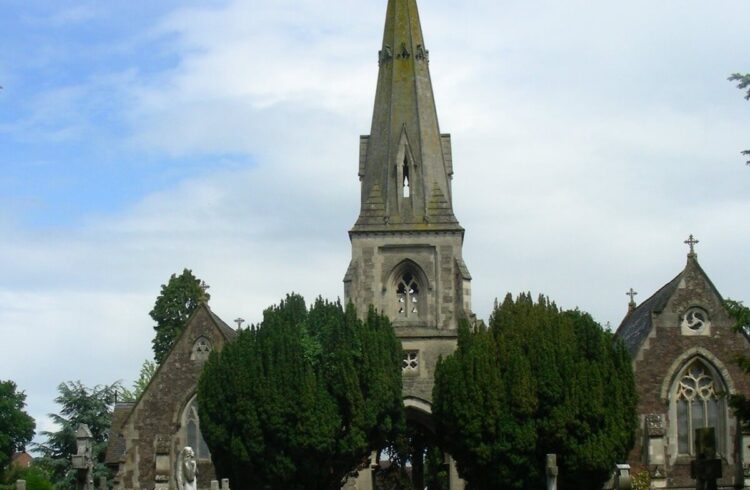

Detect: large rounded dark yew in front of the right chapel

[433,294,636,490]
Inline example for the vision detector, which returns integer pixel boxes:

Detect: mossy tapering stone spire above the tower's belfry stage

[353,0,462,231]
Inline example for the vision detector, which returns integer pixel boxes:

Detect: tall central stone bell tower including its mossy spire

[344,0,473,406]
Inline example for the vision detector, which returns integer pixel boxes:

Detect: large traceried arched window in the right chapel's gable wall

[674,360,726,455]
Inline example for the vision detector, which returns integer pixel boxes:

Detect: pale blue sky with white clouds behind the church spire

[0,0,750,442]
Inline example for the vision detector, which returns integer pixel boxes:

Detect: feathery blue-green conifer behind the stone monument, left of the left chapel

[35,381,121,490]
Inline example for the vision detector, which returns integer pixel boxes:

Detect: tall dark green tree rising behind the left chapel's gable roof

[149,269,210,364]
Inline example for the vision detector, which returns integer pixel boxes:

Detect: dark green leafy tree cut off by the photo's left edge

[0,380,36,474]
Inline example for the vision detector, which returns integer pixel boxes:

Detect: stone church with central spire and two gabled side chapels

[107,0,750,490]
